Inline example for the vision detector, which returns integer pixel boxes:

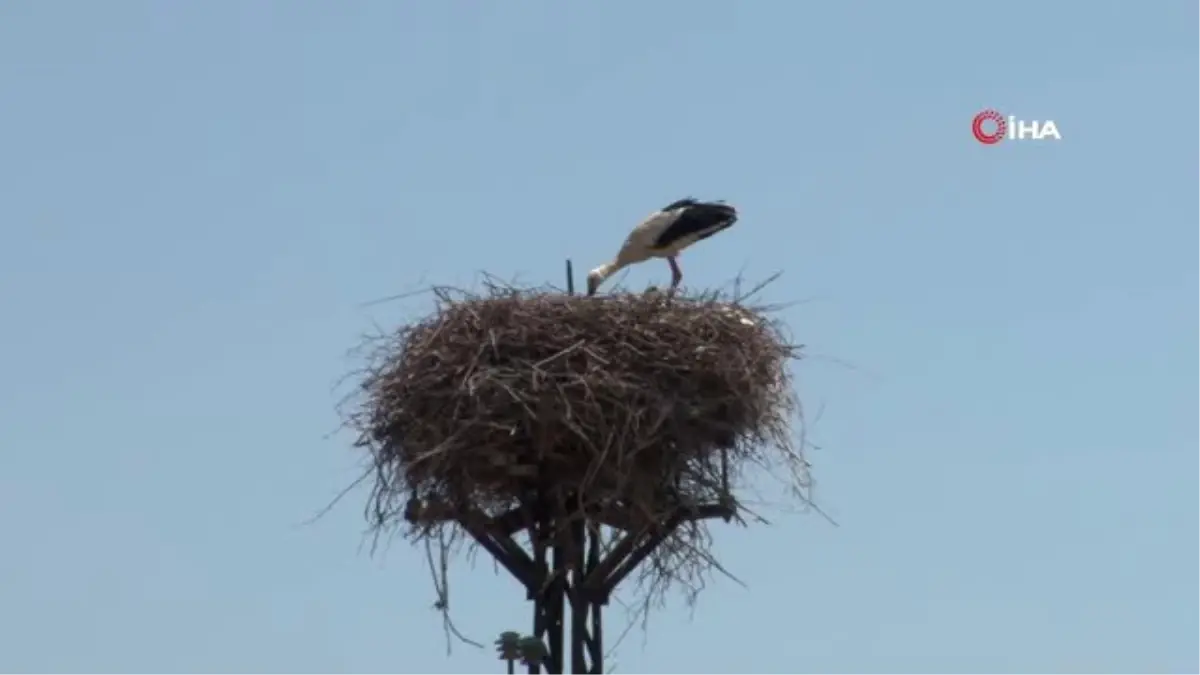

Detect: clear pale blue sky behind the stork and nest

[0,0,1200,675]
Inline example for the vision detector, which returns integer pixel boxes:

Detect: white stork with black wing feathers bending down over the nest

[588,197,738,295]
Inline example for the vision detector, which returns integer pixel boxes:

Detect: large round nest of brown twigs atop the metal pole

[349,276,808,612]
